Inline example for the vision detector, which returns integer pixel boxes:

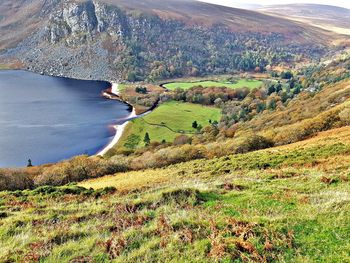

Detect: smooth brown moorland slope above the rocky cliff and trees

[102,0,332,41]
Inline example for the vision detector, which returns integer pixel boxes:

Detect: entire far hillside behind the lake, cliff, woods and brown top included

[0,0,338,81]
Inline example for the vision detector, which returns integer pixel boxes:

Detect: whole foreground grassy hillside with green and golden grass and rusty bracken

[0,127,350,262]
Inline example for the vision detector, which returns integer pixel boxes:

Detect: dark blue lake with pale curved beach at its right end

[0,70,130,167]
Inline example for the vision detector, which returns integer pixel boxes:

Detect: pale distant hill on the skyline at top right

[258,4,350,35]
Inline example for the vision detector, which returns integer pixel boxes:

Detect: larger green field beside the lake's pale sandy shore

[119,101,221,148]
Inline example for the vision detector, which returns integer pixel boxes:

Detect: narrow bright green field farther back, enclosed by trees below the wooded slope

[164,79,262,90]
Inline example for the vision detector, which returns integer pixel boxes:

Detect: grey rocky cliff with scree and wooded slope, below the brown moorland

[0,0,332,81]
